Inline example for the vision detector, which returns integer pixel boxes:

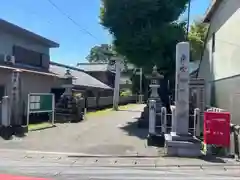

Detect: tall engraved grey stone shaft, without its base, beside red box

[175,42,190,135]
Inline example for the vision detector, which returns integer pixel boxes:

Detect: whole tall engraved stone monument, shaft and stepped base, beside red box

[165,42,201,157]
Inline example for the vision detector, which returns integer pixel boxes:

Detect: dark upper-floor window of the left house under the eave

[13,46,42,67]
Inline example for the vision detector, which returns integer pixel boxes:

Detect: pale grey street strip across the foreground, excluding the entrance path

[0,151,240,180]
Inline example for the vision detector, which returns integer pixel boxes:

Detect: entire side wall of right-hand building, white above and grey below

[199,0,240,114]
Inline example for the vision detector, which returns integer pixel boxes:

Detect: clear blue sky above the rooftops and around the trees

[0,0,210,65]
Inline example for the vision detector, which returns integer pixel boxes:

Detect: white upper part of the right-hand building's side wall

[199,0,240,104]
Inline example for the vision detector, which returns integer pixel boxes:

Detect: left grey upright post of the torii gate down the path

[111,57,121,111]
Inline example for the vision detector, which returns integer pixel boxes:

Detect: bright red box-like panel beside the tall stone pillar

[204,112,230,147]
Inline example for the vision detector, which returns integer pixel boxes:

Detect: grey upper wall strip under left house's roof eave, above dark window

[0,29,49,55]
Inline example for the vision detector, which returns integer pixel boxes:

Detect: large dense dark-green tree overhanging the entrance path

[100,0,188,73]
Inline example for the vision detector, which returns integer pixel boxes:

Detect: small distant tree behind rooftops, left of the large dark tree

[86,44,115,63]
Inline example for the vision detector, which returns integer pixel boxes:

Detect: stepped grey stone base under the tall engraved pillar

[164,133,202,157]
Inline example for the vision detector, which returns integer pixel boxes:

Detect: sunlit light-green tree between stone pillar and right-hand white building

[188,21,208,61]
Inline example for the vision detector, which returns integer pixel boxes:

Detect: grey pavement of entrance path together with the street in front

[0,105,240,180]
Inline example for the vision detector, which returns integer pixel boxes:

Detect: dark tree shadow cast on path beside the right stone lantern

[120,121,148,139]
